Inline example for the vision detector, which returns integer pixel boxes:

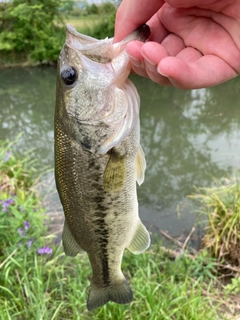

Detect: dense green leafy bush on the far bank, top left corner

[0,0,65,62]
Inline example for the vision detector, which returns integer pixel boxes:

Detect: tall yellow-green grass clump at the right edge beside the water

[190,178,240,266]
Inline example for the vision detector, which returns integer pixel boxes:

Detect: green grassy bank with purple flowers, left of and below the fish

[0,143,239,320]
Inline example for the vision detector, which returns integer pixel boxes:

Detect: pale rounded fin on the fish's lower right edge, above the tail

[127,220,150,254]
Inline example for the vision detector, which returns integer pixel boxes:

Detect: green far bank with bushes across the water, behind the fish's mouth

[0,0,116,68]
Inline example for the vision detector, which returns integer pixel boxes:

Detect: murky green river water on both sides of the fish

[0,67,240,242]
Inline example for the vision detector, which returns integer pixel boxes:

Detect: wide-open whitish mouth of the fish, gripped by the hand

[60,24,151,86]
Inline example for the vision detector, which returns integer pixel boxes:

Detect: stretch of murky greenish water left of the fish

[0,68,56,166]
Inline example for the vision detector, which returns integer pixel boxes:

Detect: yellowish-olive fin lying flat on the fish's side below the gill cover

[103,153,126,192]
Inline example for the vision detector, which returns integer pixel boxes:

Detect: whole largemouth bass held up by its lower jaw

[54,25,150,311]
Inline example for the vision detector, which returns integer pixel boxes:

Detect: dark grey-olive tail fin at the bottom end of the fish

[87,279,133,311]
